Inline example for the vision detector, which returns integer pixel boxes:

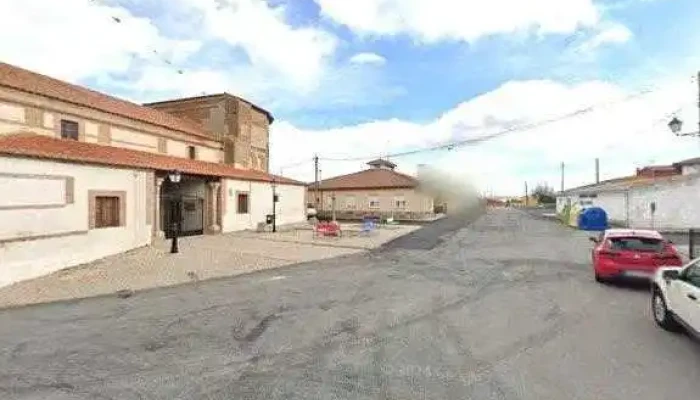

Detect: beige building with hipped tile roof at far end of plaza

[308,159,435,220]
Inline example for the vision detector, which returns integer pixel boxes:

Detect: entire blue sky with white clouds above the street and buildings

[0,0,700,194]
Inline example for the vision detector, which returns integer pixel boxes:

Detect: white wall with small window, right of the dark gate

[222,180,306,232]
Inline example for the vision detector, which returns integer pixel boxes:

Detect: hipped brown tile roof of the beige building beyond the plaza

[309,168,418,190]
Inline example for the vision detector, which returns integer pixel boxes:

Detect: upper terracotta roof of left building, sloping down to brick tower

[0,62,215,140]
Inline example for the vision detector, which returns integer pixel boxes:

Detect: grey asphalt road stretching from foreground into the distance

[0,210,700,400]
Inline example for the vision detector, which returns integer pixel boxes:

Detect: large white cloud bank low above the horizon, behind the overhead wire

[271,79,698,194]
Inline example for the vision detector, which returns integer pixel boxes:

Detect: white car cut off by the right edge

[651,258,700,339]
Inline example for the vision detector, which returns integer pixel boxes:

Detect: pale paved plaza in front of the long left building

[0,226,418,308]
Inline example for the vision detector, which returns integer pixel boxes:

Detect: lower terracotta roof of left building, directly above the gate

[0,132,306,186]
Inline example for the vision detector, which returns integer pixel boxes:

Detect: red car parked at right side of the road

[590,229,683,282]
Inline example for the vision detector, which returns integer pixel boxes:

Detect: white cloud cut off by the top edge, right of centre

[314,0,601,42]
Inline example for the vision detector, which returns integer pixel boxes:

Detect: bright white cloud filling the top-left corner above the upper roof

[0,0,201,82]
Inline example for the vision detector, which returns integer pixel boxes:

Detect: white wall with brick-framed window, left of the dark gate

[0,157,151,286]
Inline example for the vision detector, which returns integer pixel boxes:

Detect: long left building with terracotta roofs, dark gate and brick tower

[0,63,305,286]
